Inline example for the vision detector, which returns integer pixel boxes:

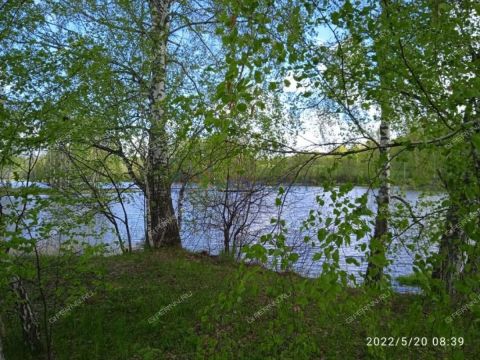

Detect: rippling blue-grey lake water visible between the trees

[2,185,441,292]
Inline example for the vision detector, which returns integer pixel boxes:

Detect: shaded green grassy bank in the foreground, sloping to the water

[5,249,480,360]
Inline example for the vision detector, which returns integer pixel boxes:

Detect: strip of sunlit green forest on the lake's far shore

[3,139,446,191]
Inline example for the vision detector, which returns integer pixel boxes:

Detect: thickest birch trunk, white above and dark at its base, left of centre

[145,0,181,248]
